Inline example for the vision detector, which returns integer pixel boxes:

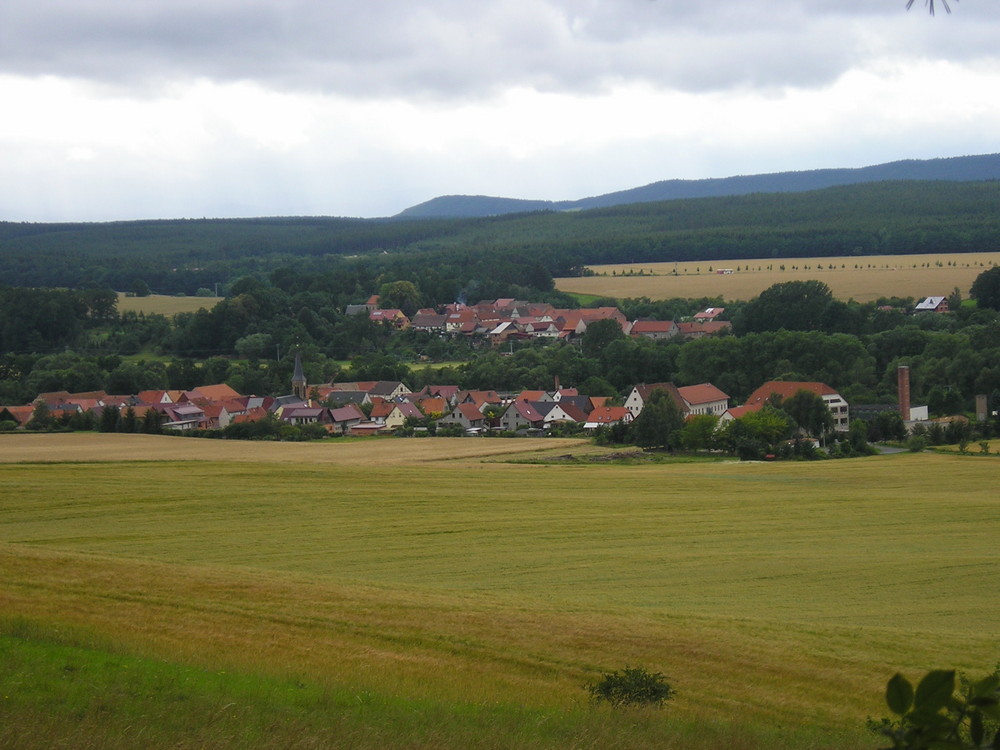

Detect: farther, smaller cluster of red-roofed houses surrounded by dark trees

[347,294,731,346]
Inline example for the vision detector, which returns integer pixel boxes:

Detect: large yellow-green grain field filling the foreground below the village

[0,435,1000,748]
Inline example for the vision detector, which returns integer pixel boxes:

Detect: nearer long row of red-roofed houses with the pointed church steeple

[0,356,850,435]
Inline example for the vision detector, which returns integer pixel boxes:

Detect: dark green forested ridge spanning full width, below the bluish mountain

[0,181,1000,296]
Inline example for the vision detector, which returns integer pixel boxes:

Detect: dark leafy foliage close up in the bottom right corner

[869,668,1000,750]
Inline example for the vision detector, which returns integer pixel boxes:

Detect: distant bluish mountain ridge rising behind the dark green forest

[394,154,1000,219]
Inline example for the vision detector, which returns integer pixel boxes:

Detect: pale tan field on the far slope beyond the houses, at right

[556,253,1000,302]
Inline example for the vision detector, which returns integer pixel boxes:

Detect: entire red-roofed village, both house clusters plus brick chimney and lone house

[0,295,968,437]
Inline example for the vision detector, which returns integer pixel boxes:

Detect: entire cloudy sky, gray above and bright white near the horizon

[0,0,1000,222]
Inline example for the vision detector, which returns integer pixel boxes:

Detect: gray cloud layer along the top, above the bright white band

[0,0,1000,98]
